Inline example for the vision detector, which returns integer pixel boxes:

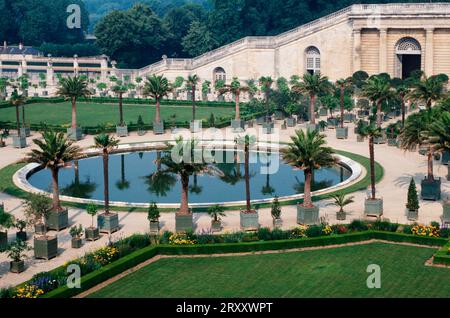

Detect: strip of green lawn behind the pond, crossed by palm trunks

[0,102,233,127]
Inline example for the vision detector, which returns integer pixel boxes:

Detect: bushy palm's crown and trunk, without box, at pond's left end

[24,131,83,212]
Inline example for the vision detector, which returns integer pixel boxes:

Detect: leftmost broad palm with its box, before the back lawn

[56,76,91,141]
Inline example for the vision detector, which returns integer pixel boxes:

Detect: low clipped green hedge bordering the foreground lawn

[43,231,450,298]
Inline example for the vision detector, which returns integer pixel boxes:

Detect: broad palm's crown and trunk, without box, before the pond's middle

[157,137,220,216]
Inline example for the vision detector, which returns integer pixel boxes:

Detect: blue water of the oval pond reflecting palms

[28,151,352,204]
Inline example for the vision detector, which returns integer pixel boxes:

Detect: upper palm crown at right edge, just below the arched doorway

[409,74,448,109]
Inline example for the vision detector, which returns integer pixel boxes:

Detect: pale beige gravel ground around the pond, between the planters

[0,122,450,287]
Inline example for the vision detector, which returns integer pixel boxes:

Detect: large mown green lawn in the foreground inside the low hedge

[90,243,450,298]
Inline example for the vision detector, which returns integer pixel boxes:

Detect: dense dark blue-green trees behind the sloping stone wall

[0,0,450,68]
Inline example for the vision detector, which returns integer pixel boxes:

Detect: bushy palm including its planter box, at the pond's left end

[24,130,83,231]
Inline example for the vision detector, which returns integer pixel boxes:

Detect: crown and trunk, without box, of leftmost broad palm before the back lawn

[56,76,92,129]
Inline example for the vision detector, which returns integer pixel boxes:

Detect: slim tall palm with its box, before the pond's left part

[93,134,119,234]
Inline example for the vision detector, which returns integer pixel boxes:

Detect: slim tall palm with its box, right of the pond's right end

[360,124,383,217]
